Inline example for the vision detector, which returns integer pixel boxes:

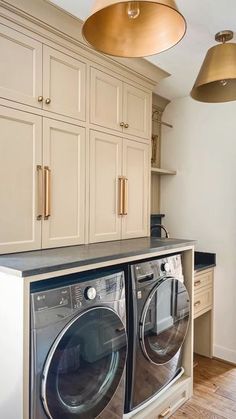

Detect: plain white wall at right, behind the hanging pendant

[161,97,236,362]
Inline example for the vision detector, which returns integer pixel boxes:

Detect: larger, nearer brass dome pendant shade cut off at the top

[82,0,186,57]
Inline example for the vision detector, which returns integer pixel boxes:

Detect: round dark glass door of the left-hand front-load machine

[42,307,127,419]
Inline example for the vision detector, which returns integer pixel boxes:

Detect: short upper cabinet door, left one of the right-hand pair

[90,68,123,132]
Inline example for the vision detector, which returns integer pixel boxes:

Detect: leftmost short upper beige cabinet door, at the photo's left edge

[0,25,42,107]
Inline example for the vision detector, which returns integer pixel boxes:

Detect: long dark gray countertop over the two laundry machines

[0,237,194,277]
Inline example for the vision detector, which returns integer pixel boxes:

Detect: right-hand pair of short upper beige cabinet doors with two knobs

[90,68,151,139]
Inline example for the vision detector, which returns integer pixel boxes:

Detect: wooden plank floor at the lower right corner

[171,356,236,419]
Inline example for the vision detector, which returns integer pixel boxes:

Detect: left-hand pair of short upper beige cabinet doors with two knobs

[0,25,86,121]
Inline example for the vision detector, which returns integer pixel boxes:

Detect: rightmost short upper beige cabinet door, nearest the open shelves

[123,83,152,139]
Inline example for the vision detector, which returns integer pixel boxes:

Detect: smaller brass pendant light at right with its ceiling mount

[191,31,236,103]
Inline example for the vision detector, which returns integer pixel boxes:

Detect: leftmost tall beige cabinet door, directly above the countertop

[0,106,42,253]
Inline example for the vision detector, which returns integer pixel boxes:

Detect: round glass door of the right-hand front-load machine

[140,277,190,365]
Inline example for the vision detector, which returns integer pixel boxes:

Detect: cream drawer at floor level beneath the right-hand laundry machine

[134,382,189,419]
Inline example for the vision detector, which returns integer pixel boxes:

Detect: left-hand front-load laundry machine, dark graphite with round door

[30,272,127,419]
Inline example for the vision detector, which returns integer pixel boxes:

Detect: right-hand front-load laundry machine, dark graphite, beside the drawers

[125,254,190,413]
